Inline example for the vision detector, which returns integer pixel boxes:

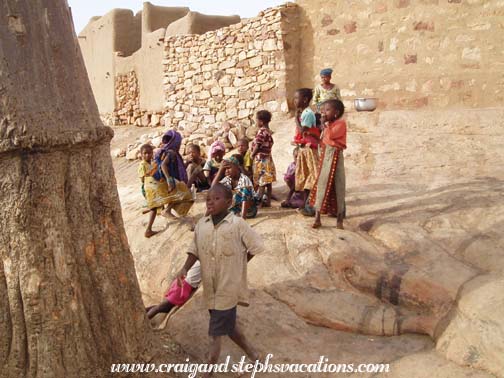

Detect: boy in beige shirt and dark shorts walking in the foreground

[177,183,264,377]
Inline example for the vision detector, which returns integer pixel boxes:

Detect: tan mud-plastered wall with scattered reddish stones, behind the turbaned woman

[297,0,504,109]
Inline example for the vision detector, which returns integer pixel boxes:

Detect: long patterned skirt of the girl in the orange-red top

[310,146,345,216]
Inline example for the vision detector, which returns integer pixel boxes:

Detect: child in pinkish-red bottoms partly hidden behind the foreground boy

[145,261,201,319]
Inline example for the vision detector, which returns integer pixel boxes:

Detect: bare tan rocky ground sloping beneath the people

[112,109,504,378]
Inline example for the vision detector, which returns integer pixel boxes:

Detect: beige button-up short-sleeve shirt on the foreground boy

[188,213,264,310]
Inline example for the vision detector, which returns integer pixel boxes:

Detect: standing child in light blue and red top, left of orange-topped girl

[294,88,320,216]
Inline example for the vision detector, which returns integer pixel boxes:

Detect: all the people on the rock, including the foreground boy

[139,70,346,376]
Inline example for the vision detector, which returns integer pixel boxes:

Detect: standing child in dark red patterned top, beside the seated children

[251,110,276,207]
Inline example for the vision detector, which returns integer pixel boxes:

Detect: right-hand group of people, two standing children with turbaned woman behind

[288,69,347,229]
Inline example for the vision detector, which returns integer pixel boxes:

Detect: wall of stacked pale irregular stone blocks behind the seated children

[163,4,297,151]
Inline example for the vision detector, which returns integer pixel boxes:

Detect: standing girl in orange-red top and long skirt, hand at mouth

[310,100,347,229]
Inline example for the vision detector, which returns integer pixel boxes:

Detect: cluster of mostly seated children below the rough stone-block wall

[138,110,276,237]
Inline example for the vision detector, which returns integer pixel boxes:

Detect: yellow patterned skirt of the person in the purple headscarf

[144,177,194,216]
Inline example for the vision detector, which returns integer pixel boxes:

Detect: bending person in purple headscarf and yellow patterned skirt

[145,130,194,216]
